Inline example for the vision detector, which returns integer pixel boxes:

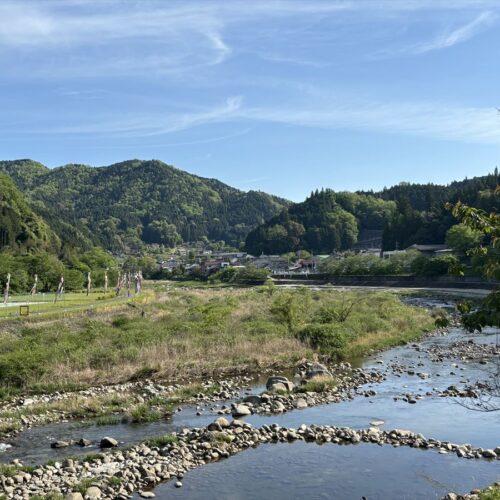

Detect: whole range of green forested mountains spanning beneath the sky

[0,160,500,257]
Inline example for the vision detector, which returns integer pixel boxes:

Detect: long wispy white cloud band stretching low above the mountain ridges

[20,92,500,146]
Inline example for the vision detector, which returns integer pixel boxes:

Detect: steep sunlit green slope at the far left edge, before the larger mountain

[0,173,60,253]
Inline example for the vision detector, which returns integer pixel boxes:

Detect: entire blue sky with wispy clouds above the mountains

[0,0,500,200]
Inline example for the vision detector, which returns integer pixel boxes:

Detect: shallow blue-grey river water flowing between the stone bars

[0,298,500,499]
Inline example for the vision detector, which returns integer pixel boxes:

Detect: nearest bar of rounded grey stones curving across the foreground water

[1,417,500,500]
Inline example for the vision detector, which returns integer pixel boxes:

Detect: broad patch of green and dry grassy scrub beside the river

[0,286,433,396]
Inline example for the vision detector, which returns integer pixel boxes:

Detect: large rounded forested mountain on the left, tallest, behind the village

[0,160,289,252]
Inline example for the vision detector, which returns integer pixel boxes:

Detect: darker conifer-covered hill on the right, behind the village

[246,174,500,254]
